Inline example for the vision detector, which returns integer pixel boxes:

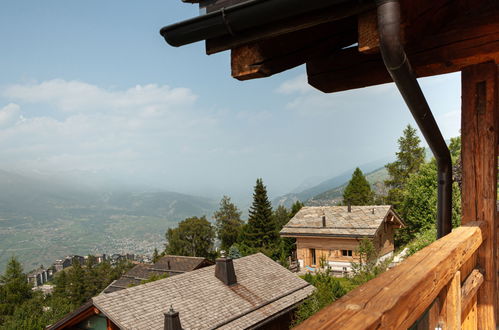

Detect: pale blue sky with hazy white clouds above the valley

[0,0,460,204]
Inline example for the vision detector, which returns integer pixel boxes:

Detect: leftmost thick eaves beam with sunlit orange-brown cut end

[231,18,357,80]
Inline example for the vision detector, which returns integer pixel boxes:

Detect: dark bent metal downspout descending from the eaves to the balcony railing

[376,0,452,238]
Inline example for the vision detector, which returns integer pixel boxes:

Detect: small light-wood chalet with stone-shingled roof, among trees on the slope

[280,205,403,273]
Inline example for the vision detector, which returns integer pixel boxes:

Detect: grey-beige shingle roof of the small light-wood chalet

[281,205,401,237]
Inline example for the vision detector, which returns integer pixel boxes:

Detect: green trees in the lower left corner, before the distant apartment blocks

[0,256,133,330]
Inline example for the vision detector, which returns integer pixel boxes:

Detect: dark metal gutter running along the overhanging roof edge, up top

[160,0,366,47]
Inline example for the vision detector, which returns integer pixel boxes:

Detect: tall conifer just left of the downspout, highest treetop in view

[385,125,425,210]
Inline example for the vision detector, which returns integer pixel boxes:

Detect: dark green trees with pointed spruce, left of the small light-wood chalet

[164,178,303,263]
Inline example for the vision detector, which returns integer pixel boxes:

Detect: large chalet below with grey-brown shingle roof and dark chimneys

[48,253,314,330]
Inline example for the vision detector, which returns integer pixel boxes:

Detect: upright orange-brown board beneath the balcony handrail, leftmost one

[440,271,461,330]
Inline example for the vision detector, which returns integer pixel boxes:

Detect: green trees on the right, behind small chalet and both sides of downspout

[343,125,461,246]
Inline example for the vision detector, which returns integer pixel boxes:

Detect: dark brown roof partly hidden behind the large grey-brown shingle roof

[103,255,213,293]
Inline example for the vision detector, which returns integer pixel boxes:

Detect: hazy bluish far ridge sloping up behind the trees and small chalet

[272,160,390,207]
